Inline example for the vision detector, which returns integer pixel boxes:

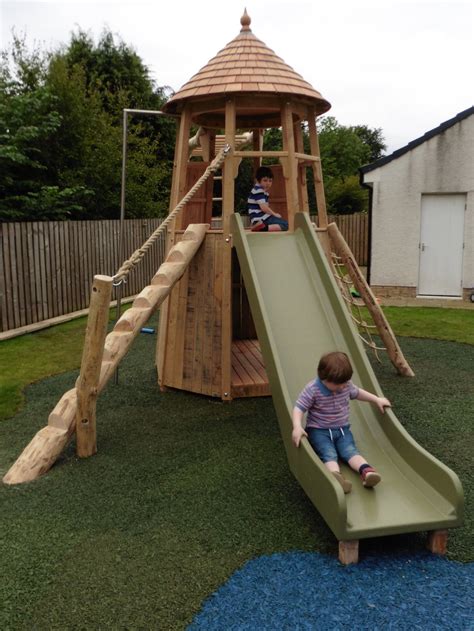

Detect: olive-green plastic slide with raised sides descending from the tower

[232,213,463,540]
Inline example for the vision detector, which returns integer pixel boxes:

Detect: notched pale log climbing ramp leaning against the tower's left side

[3,224,209,484]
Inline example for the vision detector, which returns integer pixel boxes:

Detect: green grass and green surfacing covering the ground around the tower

[0,308,474,630]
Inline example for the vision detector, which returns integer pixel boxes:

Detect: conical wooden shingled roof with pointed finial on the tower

[165,11,331,114]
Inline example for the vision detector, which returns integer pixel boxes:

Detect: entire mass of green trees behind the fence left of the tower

[0,32,175,221]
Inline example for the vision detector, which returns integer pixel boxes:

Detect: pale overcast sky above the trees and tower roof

[0,0,474,152]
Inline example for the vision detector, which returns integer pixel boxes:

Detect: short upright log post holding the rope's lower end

[76,276,113,458]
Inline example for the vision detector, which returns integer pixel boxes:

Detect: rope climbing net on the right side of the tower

[331,252,387,363]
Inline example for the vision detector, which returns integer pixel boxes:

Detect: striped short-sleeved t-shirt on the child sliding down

[295,379,359,429]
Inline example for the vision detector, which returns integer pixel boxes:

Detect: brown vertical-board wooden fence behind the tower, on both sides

[0,215,368,332]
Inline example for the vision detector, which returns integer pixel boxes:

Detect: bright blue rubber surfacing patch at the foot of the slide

[188,552,474,631]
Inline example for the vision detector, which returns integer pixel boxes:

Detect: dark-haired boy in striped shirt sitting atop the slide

[247,167,288,232]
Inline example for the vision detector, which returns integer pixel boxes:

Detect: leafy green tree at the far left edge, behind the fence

[0,36,90,221]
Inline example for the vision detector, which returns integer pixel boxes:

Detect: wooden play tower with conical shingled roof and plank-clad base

[156,12,412,400]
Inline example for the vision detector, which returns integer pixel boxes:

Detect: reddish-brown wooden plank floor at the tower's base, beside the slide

[232,340,270,398]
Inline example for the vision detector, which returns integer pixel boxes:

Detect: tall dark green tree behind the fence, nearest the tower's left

[48,31,175,218]
